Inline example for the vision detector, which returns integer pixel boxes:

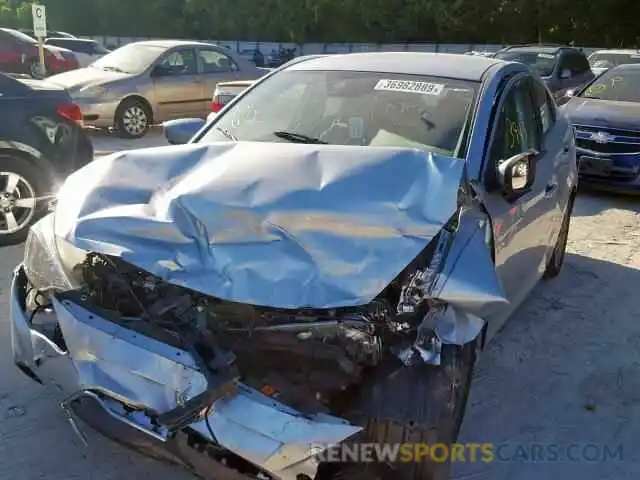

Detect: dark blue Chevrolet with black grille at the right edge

[563,64,640,193]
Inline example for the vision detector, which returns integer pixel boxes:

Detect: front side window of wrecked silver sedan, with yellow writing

[490,80,540,167]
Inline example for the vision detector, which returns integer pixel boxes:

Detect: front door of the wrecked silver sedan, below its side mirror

[483,74,552,330]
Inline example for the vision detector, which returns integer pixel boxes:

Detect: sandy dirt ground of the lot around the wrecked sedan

[0,135,640,480]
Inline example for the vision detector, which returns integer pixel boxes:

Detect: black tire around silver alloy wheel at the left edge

[0,158,46,246]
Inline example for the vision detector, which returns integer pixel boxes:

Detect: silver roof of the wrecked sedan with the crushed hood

[287,52,501,81]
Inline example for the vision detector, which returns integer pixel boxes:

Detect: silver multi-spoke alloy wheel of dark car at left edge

[0,171,37,235]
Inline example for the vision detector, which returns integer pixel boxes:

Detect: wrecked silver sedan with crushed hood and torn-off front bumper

[11,53,577,480]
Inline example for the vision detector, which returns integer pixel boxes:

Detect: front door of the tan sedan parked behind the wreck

[151,47,204,122]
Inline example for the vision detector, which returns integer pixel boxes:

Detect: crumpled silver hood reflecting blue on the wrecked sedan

[55,142,464,308]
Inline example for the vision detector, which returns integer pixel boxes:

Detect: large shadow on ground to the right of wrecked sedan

[453,254,640,480]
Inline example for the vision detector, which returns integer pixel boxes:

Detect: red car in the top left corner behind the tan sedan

[0,28,79,78]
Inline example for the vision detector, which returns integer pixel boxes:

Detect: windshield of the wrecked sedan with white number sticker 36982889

[199,70,478,156]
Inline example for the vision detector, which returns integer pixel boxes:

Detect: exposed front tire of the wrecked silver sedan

[335,340,480,480]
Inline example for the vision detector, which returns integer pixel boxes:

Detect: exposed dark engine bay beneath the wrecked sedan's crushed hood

[74,234,438,414]
